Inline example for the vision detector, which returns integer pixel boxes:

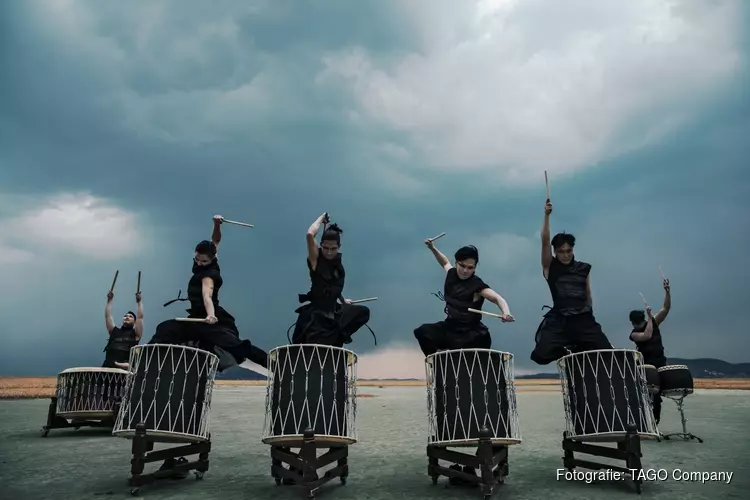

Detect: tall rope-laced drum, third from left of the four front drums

[425,349,521,446]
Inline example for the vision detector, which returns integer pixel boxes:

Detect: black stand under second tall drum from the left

[271,428,349,498]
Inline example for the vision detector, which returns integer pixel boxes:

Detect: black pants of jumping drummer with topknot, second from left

[292,304,370,347]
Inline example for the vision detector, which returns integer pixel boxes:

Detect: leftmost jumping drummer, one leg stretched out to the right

[149,215,268,371]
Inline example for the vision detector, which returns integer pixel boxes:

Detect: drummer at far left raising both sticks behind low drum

[102,290,143,369]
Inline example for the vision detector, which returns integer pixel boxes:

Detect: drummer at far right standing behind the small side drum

[630,278,672,425]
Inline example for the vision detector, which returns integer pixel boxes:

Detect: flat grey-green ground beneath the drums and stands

[0,385,750,500]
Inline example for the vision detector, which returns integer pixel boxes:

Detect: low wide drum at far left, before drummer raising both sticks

[55,368,128,420]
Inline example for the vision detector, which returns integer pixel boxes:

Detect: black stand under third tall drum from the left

[427,427,508,500]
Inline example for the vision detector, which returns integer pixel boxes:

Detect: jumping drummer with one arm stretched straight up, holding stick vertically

[531,199,612,365]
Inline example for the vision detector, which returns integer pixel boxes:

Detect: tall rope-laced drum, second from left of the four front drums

[263,344,357,445]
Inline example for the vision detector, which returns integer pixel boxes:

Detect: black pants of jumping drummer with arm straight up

[531,309,612,365]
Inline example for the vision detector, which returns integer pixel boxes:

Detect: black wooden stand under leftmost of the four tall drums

[128,424,211,495]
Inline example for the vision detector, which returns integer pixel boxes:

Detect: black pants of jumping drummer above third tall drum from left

[414,321,492,356]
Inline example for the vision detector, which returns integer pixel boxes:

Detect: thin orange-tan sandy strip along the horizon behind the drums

[0,377,750,399]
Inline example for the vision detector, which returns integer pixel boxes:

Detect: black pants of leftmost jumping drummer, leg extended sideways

[149,319,268,368]
